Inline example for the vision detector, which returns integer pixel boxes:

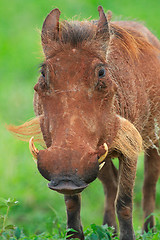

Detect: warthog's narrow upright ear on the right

[96,6,110,41]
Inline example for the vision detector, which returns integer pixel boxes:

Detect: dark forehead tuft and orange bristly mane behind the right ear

[53,21,154,59]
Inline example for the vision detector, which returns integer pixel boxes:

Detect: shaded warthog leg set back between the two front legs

[98,159,118,233]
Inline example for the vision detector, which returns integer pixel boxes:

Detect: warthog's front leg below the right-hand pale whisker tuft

[116,156,137,240]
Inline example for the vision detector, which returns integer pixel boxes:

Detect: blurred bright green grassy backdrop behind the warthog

[0,0,160,234]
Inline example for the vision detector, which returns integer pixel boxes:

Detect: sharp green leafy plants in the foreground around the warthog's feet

[0,199,160,240]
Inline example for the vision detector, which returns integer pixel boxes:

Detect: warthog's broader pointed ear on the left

[41,8,60,53]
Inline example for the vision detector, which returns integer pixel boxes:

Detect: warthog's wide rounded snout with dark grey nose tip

[37,144,102,194]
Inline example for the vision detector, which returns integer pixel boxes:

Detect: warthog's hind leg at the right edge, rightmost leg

[143,144,160,232]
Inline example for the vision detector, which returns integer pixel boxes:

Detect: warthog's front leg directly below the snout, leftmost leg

[64,194,84,240]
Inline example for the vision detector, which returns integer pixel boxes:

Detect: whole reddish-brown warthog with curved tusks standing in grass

[9,6,160,240]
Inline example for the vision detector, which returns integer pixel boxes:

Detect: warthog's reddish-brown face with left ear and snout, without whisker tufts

[31,9,118,193]
